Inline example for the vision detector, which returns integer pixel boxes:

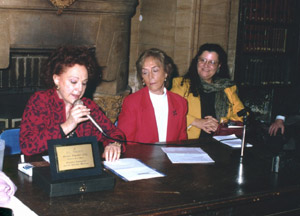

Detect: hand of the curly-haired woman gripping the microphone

[61,105,90,134]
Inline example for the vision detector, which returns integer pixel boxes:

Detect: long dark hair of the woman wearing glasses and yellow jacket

[181,43,229,97]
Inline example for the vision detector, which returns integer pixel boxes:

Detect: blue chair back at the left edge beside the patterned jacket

[0,128,21,155]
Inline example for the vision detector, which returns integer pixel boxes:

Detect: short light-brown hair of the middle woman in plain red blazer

[136,48,177,89]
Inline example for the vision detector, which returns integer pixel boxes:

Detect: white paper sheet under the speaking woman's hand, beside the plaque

[103,158,165,181]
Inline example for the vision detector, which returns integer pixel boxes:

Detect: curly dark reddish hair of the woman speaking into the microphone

[42,46,101,88]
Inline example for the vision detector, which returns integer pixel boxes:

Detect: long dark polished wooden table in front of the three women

[4,138,300,216]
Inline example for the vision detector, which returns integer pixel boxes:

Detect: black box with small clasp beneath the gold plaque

[32,167,115,197]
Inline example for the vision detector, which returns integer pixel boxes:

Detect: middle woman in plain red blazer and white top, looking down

[118,49,187,144]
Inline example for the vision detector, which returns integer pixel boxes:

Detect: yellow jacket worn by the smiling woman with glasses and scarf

[171,77,244,139]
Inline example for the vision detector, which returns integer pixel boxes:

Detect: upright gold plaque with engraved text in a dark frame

[47,136,102,181]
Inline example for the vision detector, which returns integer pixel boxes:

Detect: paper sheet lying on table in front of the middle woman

[161,147,214,163]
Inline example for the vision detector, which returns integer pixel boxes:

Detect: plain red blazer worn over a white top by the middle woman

[118,87,187,144]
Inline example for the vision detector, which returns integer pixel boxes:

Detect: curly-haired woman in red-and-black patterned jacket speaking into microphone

[20,46,125,161]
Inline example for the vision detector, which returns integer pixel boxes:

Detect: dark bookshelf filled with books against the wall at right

[234,0,300,124]
